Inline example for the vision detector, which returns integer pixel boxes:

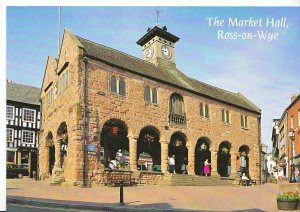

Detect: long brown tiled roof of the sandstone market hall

[76,36,261,113]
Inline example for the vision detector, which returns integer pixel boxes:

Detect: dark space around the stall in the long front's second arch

[137,125,161,171]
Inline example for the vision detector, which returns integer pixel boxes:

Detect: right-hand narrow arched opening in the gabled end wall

[57,122,69,168]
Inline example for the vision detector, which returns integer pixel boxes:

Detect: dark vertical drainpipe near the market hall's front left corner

[82,56,88,187]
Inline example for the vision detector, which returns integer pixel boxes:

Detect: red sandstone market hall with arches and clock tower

[39,26,261,184]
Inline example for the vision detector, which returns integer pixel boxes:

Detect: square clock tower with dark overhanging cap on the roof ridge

[137,25,179,67]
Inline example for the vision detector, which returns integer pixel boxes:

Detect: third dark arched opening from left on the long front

[168,132,188,174]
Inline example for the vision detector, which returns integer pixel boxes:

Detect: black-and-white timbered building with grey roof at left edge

[6,81,41,177]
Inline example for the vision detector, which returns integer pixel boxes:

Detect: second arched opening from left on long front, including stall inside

[137,126,161,171]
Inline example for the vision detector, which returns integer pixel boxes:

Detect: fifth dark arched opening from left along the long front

[217,141,231,177]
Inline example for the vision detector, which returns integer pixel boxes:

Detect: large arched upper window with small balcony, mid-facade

[169,93,186,125]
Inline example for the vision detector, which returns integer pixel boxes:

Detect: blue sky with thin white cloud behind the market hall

[6,7,300,151]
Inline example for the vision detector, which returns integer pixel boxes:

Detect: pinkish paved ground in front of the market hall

[6,177,279,211]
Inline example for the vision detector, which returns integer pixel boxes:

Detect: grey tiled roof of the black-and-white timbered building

[6,82,41,105]
